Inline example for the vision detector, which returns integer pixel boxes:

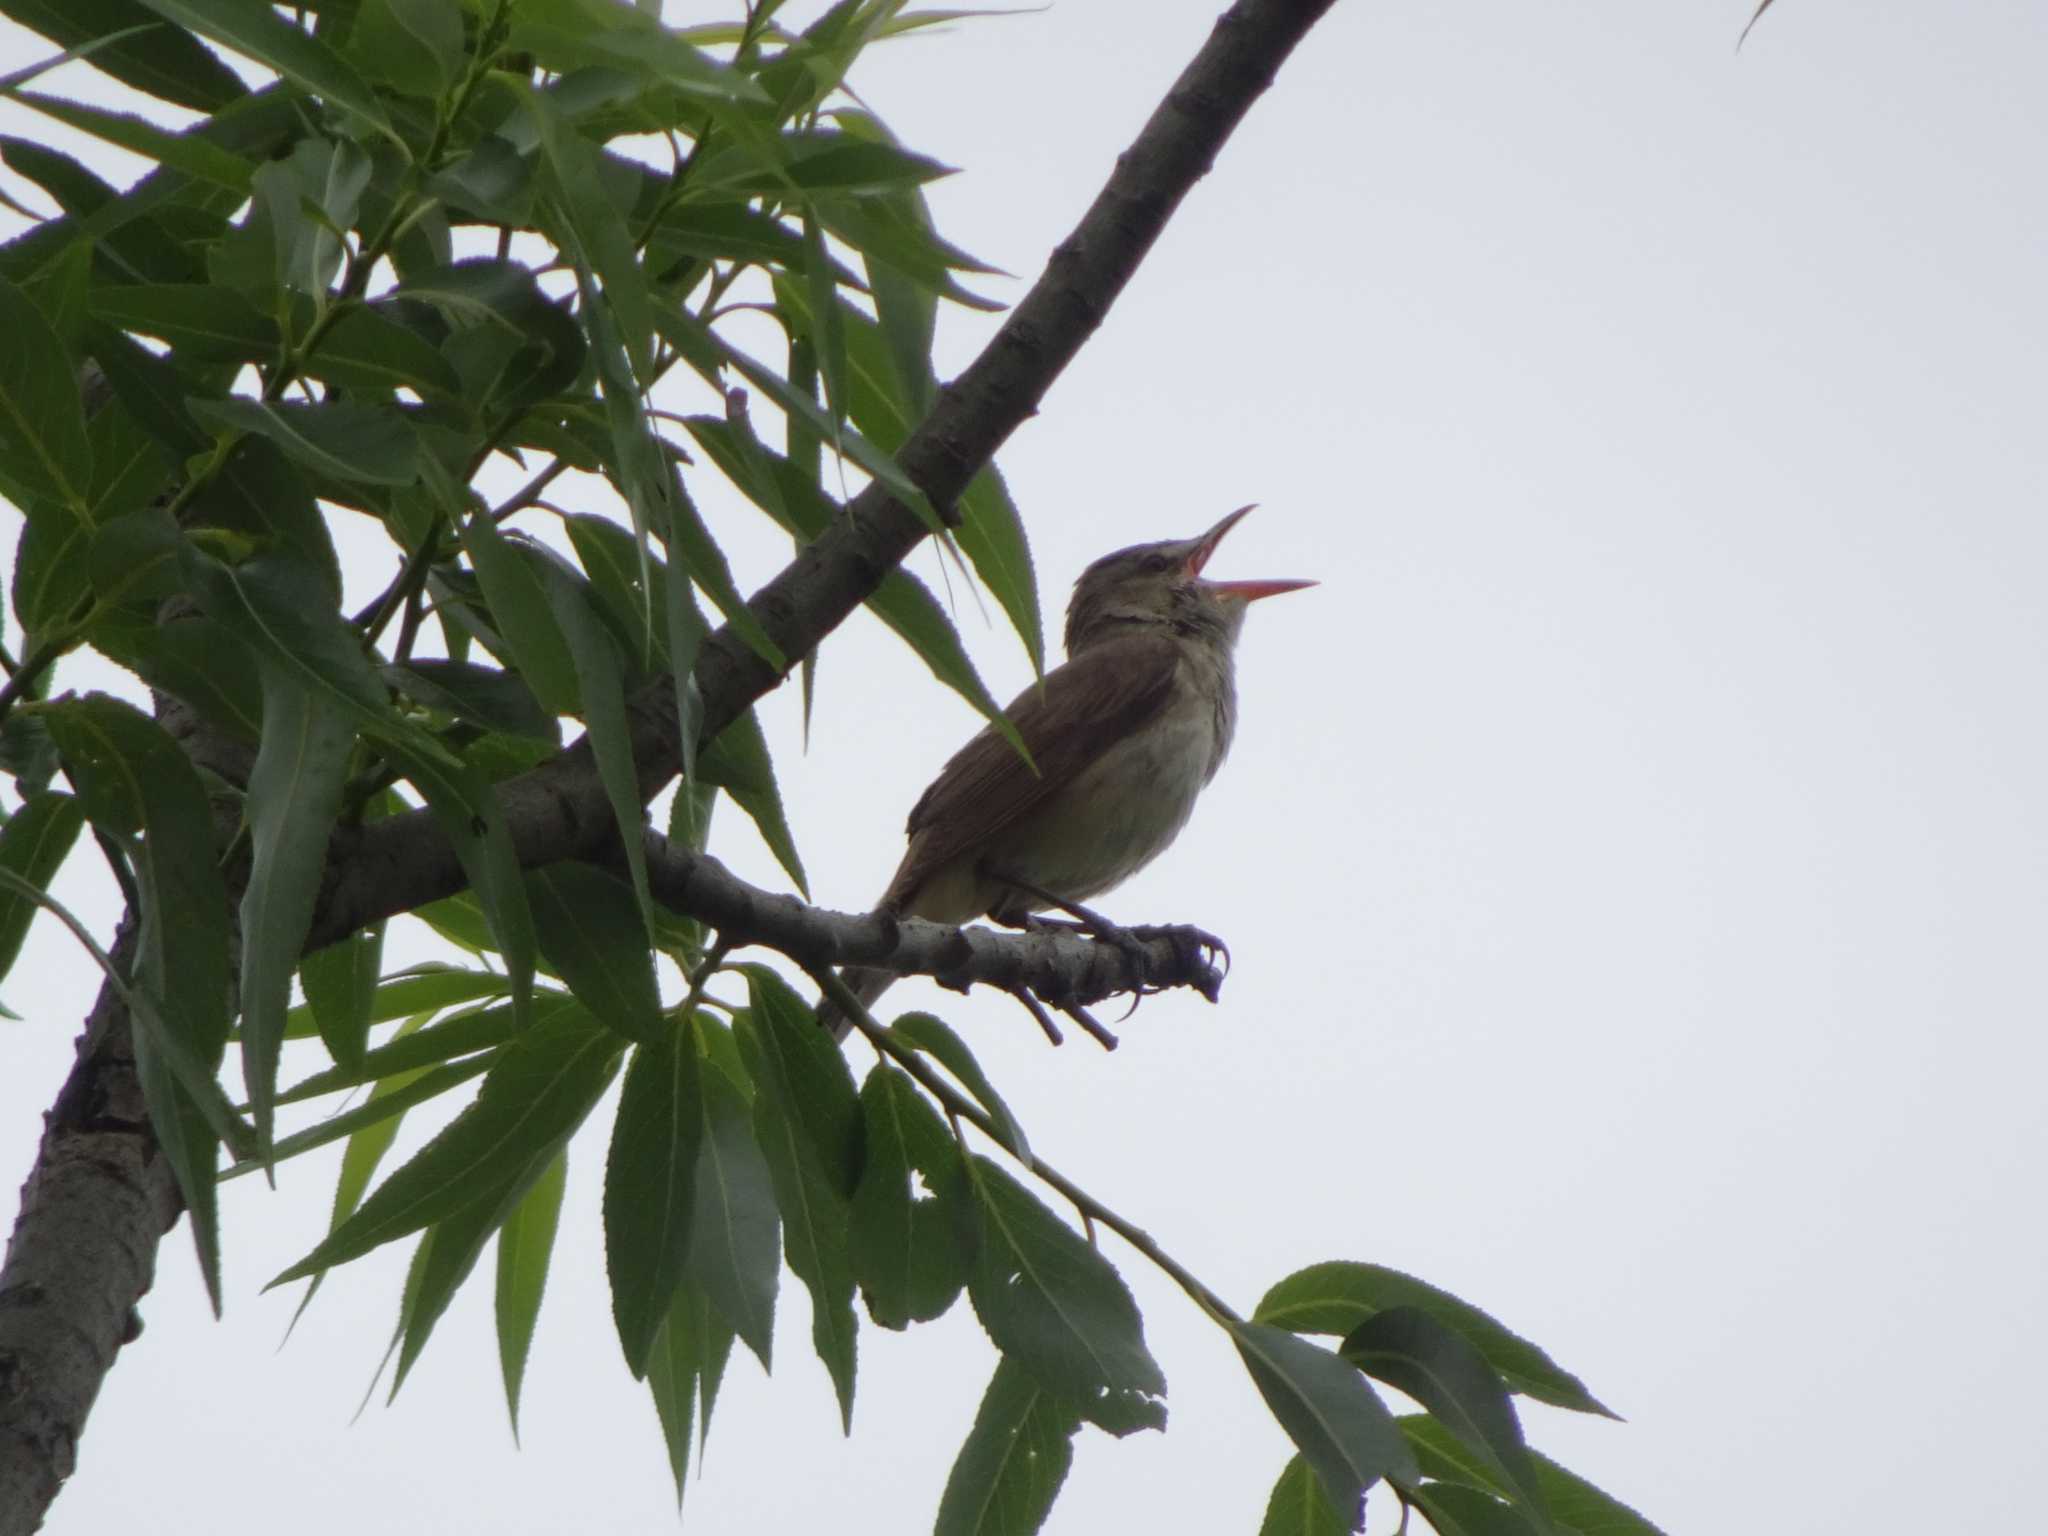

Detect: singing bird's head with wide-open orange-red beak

[1067,506,1315,655]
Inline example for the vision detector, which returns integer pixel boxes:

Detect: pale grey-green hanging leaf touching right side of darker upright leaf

[684,1020,782,1368]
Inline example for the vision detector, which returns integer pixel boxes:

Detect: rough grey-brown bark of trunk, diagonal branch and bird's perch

[0,0,1331,1536]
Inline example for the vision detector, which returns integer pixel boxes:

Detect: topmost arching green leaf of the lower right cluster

[1251,1260,1614,1419]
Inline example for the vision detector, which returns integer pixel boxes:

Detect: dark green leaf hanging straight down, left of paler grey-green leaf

[604,1028,705,1376]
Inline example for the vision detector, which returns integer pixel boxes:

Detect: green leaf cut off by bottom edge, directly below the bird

[934,1356,1081,1536]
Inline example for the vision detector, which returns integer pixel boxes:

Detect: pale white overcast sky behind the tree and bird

[0,0,2048,1536]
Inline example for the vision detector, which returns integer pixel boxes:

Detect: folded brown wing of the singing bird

[883,633,1180,907]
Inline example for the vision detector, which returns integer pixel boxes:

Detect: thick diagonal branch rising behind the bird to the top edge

[307,0,1331,948]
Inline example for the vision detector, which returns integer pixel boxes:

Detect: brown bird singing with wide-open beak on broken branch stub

[819,506,1315,1038]
